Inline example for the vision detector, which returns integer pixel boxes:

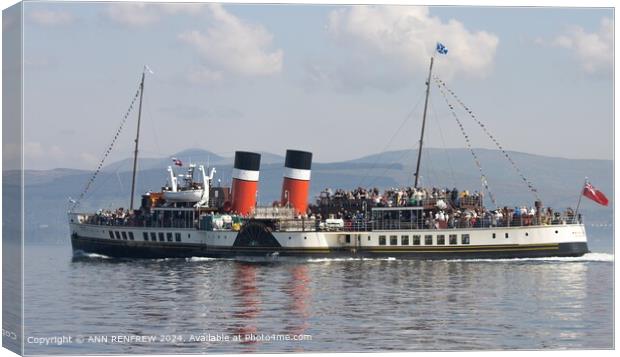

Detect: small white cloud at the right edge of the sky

[553,17,614,73]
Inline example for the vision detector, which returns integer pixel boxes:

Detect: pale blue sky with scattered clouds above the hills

[4,2,614,170]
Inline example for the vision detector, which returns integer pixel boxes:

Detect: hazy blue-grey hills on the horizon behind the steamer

[3,148,614,242]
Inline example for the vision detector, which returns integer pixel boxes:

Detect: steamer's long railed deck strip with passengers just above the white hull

[70,206,582,232]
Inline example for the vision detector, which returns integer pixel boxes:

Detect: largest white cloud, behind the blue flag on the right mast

[314,6,499,88]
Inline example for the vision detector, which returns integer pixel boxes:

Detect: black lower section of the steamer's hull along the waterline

[71,236,588,260]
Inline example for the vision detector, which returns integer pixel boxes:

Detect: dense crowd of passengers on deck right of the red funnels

[312,187,581,229]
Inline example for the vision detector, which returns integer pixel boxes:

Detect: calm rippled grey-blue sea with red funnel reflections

[24,229,613,354]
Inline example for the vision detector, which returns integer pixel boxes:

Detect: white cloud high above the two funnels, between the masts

[179,4,283,76]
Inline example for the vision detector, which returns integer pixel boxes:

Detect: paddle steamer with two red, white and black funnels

[68,59,588,259]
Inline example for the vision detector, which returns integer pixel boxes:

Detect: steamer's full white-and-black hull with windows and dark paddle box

[71,222,588,259]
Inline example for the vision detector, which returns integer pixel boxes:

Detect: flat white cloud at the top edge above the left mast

[106,2,205,27]
